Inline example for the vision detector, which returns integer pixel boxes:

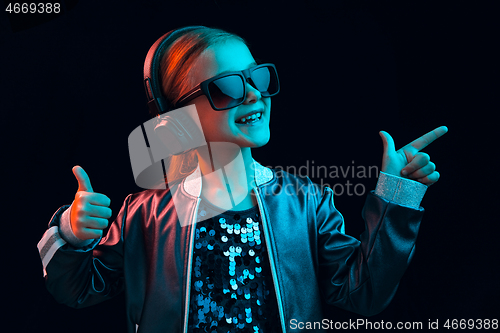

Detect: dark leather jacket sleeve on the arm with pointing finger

[317,175,425,316]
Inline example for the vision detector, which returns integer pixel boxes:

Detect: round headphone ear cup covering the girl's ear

[154,111,206,155]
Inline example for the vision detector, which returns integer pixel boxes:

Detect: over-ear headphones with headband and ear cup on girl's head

[144,26,206,155]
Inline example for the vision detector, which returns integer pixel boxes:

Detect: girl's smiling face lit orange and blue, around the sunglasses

[189,39,271,147]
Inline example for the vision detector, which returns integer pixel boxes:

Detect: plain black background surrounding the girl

[0,0,500,332]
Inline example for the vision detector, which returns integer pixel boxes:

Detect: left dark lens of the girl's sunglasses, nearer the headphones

[208,75,245,109]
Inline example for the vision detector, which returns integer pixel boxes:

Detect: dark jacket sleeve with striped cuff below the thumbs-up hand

[38,196,130,308]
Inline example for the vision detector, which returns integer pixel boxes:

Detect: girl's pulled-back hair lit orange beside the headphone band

[160,27,248,182]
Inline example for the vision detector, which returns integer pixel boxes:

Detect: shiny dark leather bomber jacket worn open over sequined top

[39,160,423,333]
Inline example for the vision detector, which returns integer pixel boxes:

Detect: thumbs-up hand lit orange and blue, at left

[70,166,111,240]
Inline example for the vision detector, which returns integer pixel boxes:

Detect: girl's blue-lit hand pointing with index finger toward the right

[379,126,448,186]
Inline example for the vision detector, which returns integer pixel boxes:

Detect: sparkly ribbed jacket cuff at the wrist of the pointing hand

[375,171,427,209]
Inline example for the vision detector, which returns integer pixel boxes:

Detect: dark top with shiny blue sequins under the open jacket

[188,201,281,333]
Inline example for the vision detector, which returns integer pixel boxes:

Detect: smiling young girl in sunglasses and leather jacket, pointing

[38,26,447,333]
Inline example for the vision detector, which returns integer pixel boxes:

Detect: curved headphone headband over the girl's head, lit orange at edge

[144,26,206,117]
